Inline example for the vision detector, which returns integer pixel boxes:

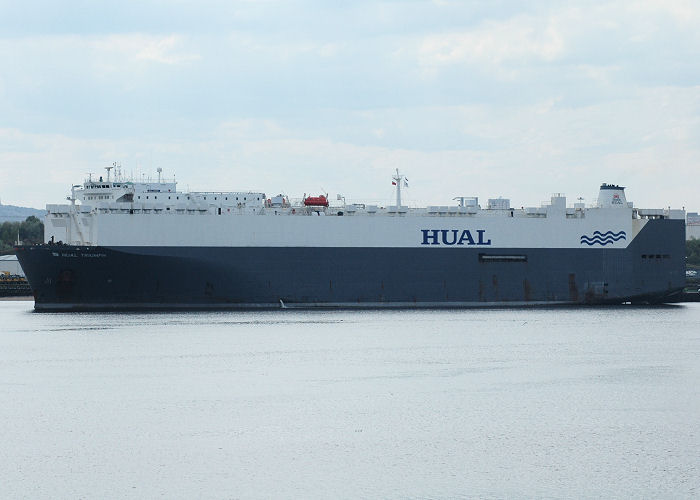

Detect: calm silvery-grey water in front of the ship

[0,302,700,499]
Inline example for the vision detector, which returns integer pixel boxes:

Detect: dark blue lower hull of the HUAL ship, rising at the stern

[17,220,685,310]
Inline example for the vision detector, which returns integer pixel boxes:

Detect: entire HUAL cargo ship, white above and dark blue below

[16,167,685,311]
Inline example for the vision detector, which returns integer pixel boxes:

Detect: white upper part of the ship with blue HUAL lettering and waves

[45,167,684,248]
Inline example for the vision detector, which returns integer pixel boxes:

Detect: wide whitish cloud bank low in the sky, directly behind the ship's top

[5,77,700,210]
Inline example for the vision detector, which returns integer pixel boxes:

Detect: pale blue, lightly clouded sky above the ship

[0,0,700,211]
